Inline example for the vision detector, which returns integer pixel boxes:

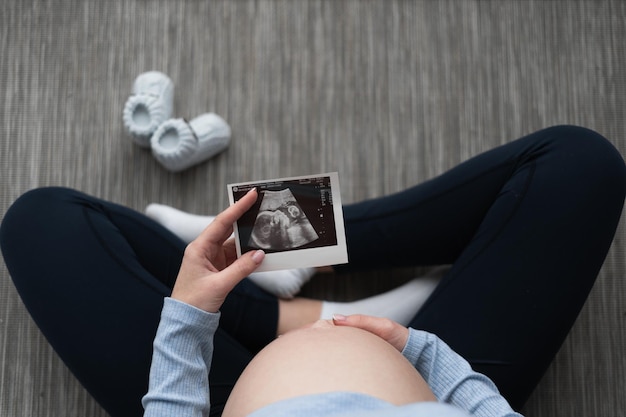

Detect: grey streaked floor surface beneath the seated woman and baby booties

[0,0,626,417]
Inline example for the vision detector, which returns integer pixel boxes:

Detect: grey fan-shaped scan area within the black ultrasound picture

[248,188,319,251]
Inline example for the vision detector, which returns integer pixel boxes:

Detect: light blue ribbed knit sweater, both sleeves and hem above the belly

[143,298,520,417]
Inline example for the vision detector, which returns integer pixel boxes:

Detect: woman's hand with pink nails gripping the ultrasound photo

[172,190,265,313]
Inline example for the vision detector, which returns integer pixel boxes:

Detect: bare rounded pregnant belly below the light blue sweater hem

[223,323,435,417]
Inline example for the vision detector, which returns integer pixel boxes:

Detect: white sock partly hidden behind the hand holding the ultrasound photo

[145,203,315,298]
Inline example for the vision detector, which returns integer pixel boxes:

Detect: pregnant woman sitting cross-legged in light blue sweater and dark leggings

[0,126,626,417]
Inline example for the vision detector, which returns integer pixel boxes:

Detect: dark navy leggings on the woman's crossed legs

[0,126,626,416]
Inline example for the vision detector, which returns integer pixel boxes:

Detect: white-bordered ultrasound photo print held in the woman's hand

[228,173,347,269]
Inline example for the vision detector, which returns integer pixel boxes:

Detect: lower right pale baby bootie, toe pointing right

[150,113,230,172]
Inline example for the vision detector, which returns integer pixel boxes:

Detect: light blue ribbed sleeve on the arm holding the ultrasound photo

[142,298,220,417]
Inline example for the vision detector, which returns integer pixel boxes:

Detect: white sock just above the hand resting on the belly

[320,276,440,326]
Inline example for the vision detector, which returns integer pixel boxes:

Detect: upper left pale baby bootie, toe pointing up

[123,71,174,148]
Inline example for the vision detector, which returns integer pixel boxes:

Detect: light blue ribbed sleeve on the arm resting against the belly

[402,329,521,417]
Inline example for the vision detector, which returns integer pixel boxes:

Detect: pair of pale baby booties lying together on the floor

[123,71,231,172]
